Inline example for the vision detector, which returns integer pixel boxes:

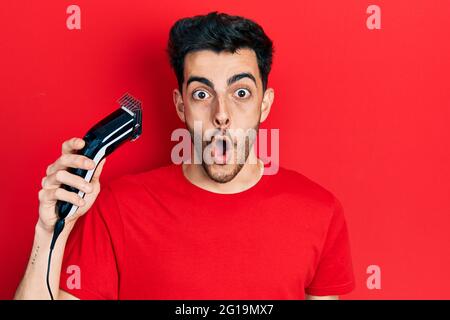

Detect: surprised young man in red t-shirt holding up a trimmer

[16,12,354,299]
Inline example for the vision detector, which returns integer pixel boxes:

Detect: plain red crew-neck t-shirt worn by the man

[60,165,354,300]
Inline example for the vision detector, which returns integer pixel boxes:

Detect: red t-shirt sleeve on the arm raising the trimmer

[60,187,119,300]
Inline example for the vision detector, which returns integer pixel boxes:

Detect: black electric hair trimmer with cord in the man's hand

[47,94,142,300]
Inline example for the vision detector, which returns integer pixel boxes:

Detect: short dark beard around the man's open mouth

[188,123,259,183]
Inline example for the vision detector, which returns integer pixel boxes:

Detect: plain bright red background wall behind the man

[0,0,450,299]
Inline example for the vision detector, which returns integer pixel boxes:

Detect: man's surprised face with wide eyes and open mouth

[174,49,271,183]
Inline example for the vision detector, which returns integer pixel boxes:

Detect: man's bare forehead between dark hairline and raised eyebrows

[184,48,259,80]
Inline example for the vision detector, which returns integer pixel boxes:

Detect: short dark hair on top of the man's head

[167,11,274,91]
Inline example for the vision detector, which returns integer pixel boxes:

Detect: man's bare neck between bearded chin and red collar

[182,148,264,193]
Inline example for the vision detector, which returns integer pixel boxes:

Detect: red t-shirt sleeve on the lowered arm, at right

[305,198,355,296]
